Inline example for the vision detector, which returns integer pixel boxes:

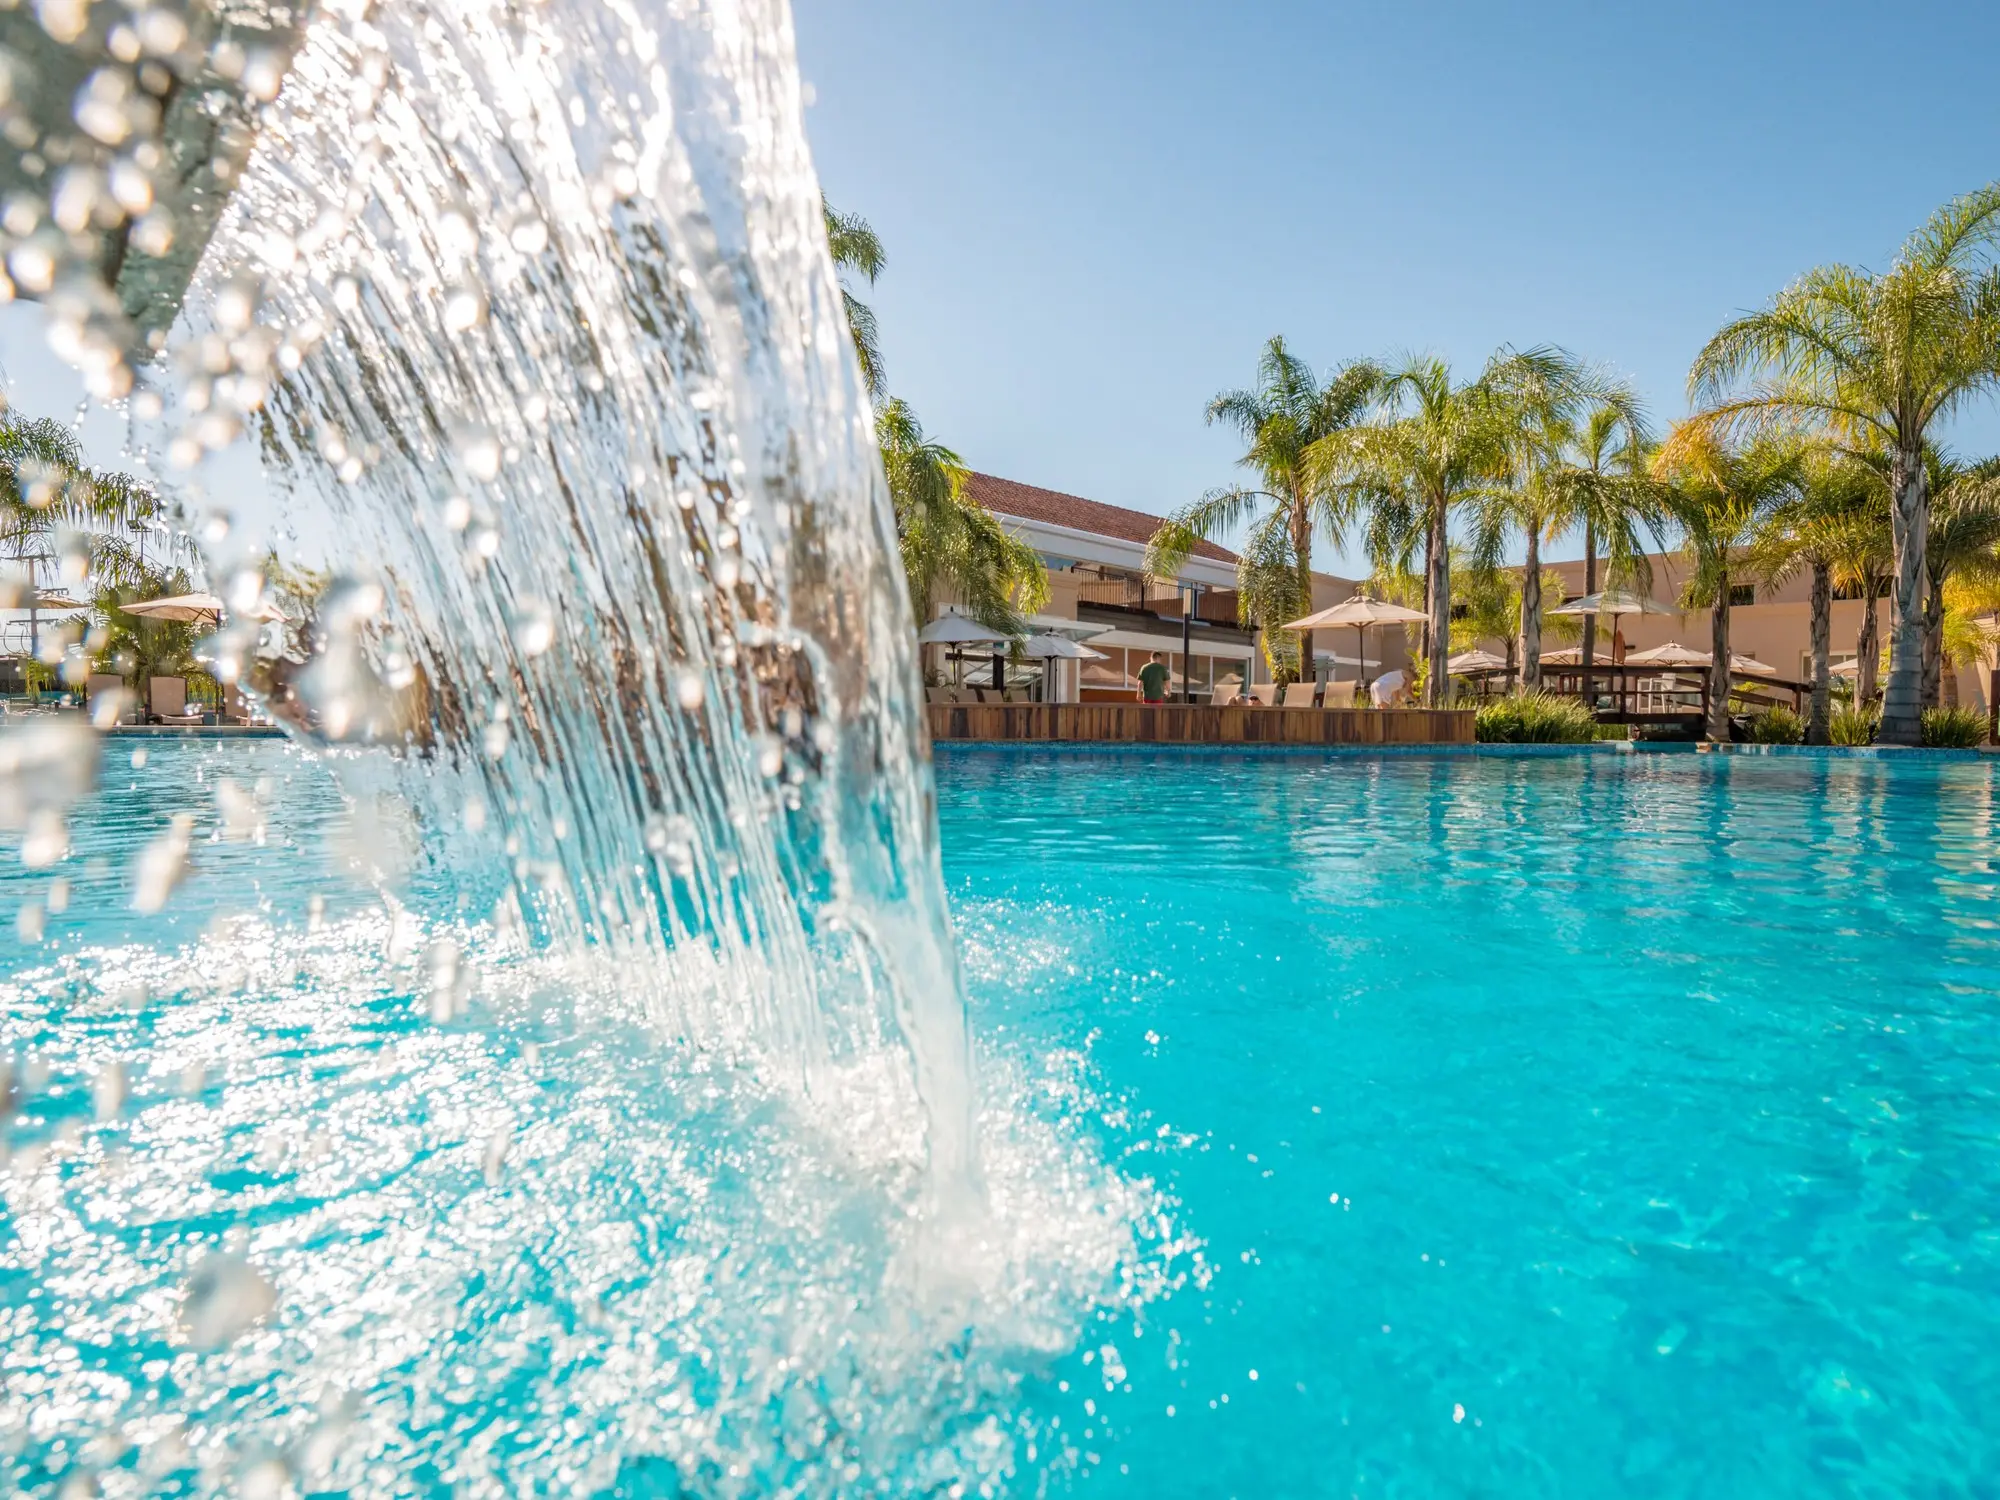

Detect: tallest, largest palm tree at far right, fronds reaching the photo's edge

[1688,182,2000,744]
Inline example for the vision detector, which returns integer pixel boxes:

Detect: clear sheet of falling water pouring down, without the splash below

[166,0,972,1178]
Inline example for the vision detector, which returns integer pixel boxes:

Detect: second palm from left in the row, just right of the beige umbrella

[1308,350,1528,708]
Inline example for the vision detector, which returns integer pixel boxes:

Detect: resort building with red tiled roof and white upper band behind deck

[944,474,1408,702]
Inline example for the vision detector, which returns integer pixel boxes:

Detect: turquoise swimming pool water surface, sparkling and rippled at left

[0,746,2000,1496]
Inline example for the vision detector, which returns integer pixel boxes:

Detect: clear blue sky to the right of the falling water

[794,0,2000,576]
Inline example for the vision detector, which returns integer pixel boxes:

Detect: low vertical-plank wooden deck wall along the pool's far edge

[928,704,1472,746]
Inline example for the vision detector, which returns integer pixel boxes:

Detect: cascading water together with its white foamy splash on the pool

[0,0,1172,1496]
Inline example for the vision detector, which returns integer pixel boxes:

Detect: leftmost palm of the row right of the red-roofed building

[1146,338,1382,680]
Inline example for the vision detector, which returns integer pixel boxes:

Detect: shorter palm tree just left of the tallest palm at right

[1748,444,1884,744]
